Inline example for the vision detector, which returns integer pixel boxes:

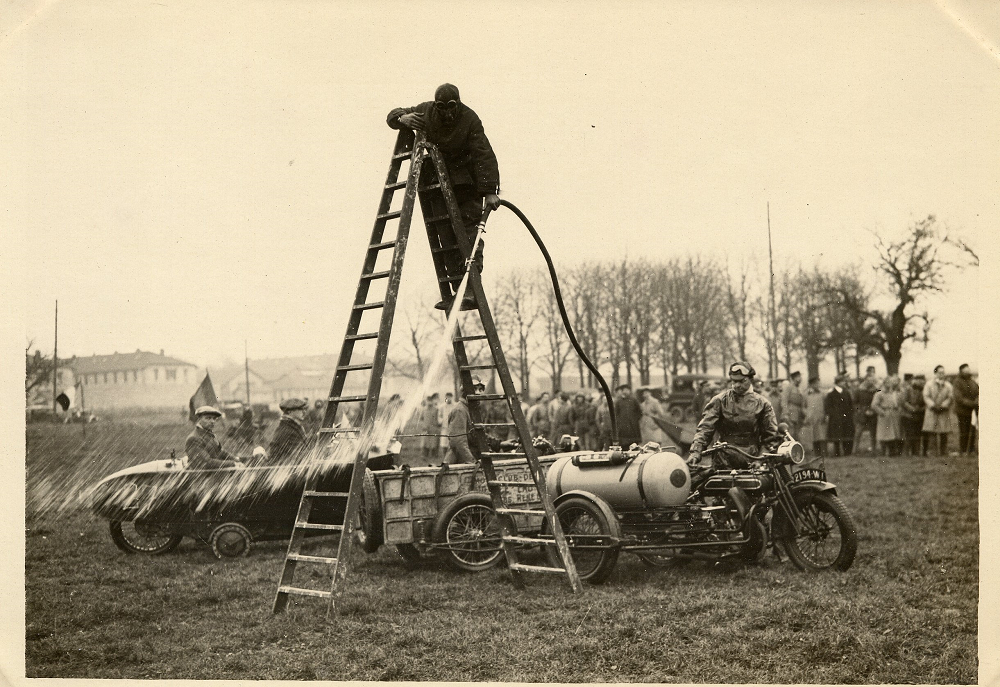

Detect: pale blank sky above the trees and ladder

[0,0,1000,376]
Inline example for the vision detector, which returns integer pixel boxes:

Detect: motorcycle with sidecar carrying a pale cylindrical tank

[547,431,857,583]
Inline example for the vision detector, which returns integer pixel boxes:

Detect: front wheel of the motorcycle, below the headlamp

[783,492,858,571]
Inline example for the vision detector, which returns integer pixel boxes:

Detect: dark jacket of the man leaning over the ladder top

[386,102,500,196]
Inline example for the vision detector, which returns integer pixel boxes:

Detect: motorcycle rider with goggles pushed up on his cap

[688,362,782,467]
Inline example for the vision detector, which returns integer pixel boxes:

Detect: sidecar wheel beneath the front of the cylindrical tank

[545,496,619,584]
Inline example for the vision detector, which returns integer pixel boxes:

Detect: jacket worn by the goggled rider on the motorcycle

[691,389,782,454]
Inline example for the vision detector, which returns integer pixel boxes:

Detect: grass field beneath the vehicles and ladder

[25,423,979,684]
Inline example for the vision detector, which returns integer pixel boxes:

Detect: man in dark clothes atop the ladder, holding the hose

[386,83,500,310]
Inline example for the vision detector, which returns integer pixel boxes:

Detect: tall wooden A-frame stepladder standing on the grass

[273,130,581,615]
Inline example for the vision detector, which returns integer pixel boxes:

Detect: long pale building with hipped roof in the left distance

[69,349,204,410]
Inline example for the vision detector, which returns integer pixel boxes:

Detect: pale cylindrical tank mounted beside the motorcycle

[545,451,691,508]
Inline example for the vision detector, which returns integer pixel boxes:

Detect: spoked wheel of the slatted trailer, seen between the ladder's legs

[434,494,503,572]
